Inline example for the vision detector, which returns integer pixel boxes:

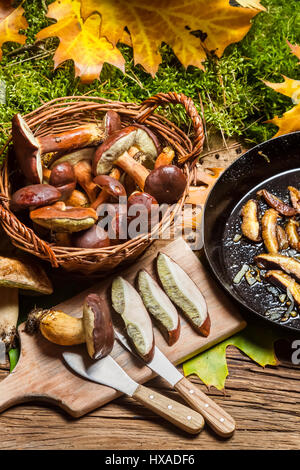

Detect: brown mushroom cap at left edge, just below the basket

[0,256,53,294]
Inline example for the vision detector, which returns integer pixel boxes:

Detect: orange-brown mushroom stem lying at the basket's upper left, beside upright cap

[36,123,105,154]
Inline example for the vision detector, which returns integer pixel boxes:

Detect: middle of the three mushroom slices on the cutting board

[138,269,180,346]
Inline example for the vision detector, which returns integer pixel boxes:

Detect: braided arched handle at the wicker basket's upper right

[137,91,205,164]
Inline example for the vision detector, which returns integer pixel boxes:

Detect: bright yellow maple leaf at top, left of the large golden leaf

[37,0,125,83]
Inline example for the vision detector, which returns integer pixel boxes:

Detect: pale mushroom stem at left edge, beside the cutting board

[0,287,19,351]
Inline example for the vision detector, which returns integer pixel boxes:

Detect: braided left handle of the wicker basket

[0,205,59,268]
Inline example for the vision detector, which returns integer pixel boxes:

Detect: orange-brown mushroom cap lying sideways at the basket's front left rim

[30,201,98,232]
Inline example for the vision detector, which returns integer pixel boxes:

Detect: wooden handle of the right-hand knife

[174,377,235,437]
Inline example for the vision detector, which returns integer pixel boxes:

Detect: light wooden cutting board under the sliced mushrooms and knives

[0,238,246,417]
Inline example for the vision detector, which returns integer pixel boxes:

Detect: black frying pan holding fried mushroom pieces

[203,132,300,331]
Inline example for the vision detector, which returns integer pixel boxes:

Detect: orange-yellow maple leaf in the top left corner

[0,0,28,60]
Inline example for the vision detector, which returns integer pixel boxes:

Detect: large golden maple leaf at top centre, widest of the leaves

[81,0,262,76]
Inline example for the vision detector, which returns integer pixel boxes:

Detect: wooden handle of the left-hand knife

[132,385,204,434]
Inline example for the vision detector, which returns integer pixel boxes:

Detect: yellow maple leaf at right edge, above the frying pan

[263,42,300,137]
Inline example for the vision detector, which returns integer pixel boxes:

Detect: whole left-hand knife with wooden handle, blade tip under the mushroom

[63,351,204,434]
